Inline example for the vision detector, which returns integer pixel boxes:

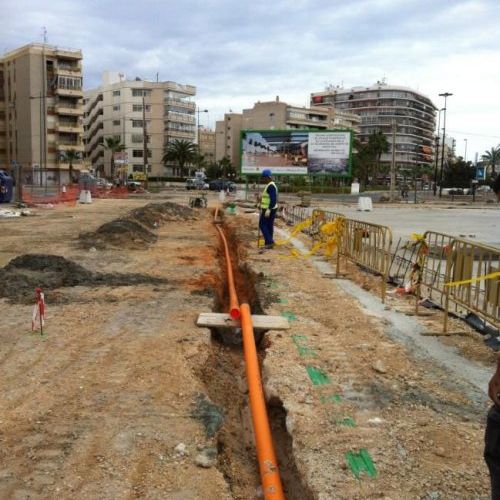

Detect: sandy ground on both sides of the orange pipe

[0,199,491,500]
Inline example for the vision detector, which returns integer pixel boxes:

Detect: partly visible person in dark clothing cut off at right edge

[484,174,500,500]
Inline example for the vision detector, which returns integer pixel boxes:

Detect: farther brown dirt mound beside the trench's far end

[80,202,196,249]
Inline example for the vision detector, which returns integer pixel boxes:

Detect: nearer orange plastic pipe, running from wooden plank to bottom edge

[240,304,285,500]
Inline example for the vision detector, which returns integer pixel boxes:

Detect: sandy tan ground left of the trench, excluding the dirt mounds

[0,200,231,500]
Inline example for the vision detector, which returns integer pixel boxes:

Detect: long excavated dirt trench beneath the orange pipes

[197,223,313,500]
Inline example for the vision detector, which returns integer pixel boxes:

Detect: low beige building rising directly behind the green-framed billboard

[215,96,361,168]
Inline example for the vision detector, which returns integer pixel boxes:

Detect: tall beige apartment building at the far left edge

[0,43,84,185]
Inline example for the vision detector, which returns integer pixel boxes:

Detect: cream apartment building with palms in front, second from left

[84,72,196,177]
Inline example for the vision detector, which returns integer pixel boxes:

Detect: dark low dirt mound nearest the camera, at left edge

[0,254,165,303]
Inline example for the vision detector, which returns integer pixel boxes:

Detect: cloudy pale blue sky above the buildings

[0,0,500,159]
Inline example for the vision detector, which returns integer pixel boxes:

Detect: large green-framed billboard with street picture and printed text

[241,129,352,176]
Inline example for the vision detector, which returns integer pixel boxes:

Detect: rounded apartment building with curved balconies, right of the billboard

[311,82,436,168]
